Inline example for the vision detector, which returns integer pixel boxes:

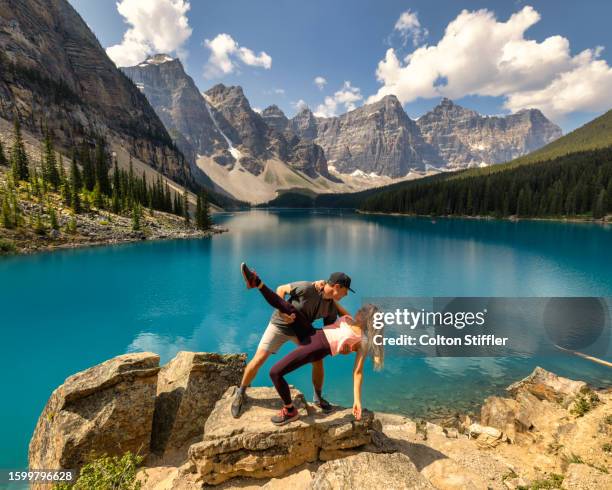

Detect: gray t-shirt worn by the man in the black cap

[270,281,338,335]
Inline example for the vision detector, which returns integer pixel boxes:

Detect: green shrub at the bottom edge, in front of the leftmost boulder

[53,452,143,490]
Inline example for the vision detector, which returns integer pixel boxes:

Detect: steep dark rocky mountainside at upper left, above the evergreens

[0,0,192,183]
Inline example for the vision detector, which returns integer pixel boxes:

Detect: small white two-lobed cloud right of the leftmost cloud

[204,33,272,78]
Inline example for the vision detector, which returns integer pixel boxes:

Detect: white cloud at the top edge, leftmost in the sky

[106,0,191,66]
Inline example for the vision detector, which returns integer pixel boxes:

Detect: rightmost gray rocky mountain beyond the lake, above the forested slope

[416,99,561,168]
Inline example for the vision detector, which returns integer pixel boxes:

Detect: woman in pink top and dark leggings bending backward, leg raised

[240,263,384,425]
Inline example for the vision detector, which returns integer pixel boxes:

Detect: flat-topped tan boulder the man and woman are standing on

[188,388,375,484]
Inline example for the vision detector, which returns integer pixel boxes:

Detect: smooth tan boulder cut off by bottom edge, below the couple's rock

[312,453,435,490]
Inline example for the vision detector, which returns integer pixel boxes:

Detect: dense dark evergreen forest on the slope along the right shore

[360,147,612,219]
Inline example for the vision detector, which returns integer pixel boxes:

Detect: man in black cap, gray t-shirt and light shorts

[231,272,354,418]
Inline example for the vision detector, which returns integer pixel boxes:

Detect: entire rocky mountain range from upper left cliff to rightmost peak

[0,0,561,207]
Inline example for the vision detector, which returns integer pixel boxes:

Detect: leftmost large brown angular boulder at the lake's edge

[29,352,159,469]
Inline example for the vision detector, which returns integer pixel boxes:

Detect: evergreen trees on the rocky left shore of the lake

[0,118,213,234]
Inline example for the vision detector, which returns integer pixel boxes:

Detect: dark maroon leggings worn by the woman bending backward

[259,284,331,405]
